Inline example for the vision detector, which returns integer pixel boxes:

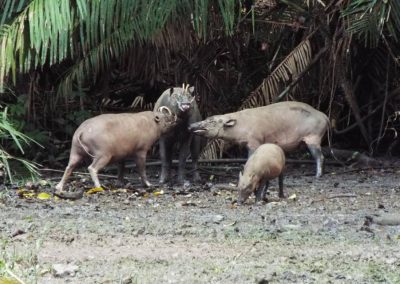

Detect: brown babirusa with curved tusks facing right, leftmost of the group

[56,107,176,192]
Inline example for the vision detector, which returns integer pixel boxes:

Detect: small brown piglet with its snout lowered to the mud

[237,144,285,205]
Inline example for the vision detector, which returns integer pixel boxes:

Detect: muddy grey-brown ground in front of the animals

[0,162,400,283]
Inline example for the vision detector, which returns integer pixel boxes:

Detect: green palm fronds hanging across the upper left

[0,0,241,95]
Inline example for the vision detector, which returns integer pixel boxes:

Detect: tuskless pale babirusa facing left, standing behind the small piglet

[189,102,329,177]
